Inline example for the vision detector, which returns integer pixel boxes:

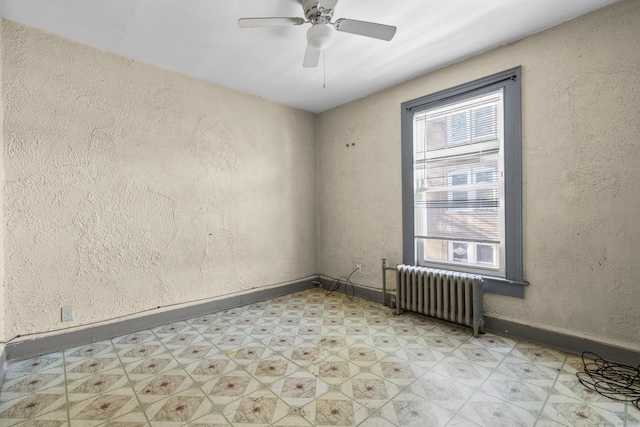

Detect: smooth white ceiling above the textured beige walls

[0,0,617,113]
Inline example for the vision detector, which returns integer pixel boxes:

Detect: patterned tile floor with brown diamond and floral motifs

[0,289,640,427]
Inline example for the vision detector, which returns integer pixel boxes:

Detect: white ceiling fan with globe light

[238,0,396,68]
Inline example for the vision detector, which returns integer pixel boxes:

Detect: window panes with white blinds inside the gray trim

[413,89,504,272]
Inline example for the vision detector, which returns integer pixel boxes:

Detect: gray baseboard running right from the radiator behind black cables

[484,316,640,367]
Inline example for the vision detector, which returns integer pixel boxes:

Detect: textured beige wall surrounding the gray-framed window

[318,0,640,350]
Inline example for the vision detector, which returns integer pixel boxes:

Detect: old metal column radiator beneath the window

[396,265,484,337]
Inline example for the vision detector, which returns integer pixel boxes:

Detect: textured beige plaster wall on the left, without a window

[2,21,317,339]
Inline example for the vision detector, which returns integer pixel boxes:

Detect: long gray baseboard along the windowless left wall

[5,278,316,364]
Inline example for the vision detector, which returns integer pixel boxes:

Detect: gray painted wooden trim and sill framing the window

[401,67,528,298]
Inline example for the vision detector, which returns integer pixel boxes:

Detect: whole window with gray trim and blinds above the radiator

[402,68,526,296]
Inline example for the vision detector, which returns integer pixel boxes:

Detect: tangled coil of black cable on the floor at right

[576,351,640,410]
